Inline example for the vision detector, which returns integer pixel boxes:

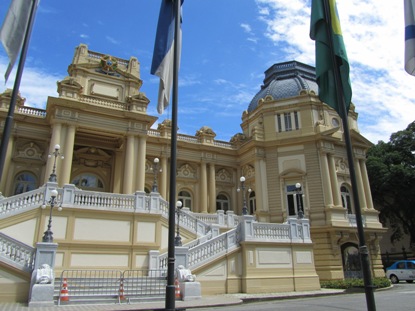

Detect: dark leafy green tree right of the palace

[366,121,415,248]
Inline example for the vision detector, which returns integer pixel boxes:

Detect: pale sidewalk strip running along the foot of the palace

[0,289,344,311]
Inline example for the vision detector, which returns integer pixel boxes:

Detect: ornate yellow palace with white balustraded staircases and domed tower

[0,44,384,300]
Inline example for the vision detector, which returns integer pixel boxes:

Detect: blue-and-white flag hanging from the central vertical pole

[151,0,183,114]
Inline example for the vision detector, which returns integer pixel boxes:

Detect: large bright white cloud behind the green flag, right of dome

[256,0,415,143]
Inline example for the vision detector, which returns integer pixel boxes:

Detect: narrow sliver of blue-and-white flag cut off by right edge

[404,0,415,76]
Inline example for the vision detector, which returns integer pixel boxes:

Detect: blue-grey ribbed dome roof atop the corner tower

[248,61,318,112]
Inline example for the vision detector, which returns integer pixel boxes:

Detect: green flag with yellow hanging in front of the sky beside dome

[310,0,352,116]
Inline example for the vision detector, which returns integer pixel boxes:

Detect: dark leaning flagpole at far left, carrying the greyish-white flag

[0,0,39,180]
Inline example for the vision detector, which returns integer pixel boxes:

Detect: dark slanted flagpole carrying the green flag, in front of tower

[323,0,376,311]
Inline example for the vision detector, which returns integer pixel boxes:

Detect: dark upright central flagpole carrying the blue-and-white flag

[165,0,181,311]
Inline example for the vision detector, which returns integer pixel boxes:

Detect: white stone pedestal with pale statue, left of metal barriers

[29,242,58,307]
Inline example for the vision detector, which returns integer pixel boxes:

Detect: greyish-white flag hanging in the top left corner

[0,0,33,82]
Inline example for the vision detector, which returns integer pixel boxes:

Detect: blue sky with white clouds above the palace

[0,0,415,143]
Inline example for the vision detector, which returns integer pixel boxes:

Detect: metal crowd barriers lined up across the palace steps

[58,269,167,305]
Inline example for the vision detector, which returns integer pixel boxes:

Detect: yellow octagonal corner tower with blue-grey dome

[234,61,383,279]
